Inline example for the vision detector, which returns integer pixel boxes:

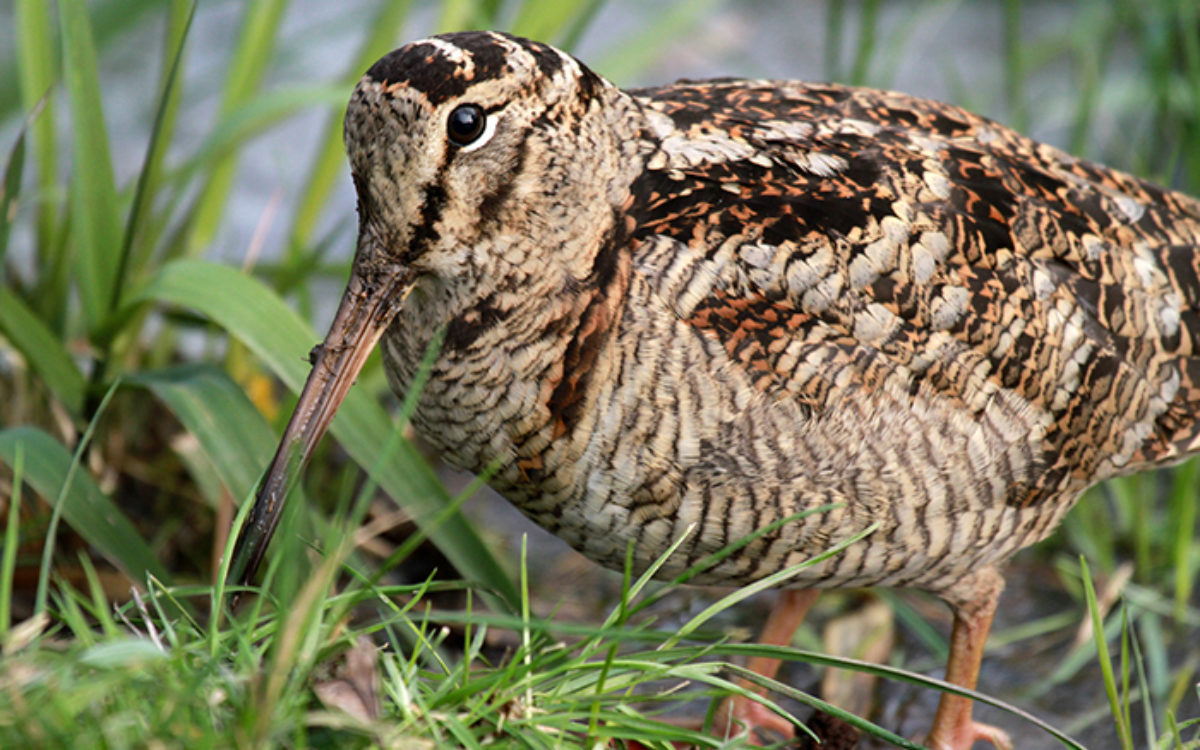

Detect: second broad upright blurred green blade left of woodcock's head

[187,0,287,254]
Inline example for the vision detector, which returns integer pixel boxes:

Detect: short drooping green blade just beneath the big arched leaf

[126,364,276,498]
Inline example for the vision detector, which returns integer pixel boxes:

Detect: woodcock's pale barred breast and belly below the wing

[384,261,1070,589]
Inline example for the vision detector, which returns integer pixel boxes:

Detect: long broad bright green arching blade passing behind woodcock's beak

[142,260,520,607]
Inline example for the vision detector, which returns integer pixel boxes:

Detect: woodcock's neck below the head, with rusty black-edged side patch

[383,219,630,488]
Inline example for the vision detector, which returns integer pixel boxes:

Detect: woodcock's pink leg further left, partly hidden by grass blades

[716,589,820,739]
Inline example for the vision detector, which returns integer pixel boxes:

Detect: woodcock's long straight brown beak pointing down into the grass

[229,244,412,584]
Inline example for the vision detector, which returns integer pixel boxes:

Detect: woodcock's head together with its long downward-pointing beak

[230,31,629,581]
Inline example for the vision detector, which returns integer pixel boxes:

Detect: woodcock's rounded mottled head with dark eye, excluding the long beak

[344,31,616,280]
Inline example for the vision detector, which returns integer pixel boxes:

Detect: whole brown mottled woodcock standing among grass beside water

[229,32,1200,749]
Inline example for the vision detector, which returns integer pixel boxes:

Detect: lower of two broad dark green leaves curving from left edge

[0,427,170,590]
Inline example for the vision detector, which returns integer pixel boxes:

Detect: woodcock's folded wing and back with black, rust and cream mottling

[629,82,1200,494]
